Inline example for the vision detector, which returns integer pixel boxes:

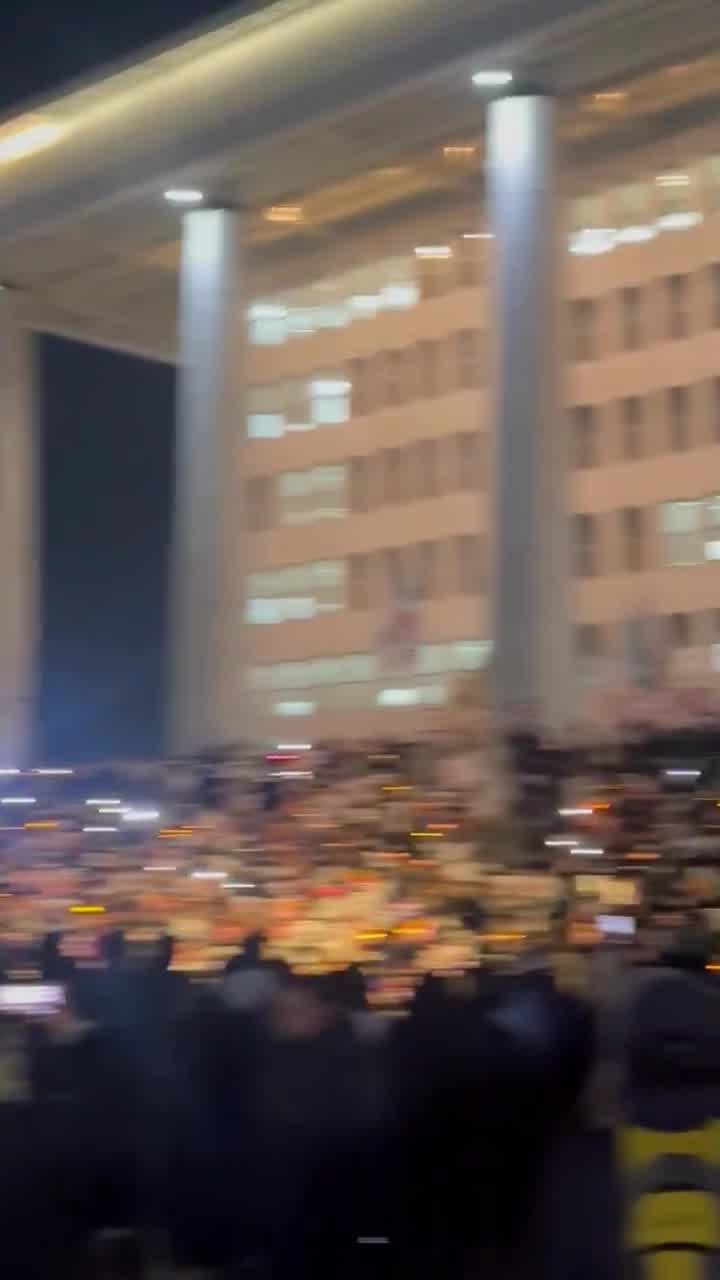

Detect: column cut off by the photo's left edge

[0,288,38,767]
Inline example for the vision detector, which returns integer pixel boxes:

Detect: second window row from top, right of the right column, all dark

[569,262,720,361]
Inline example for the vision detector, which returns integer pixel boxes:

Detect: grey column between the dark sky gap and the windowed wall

[170,209,250,753]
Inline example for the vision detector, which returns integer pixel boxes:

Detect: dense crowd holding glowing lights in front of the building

[0,731,720,1280]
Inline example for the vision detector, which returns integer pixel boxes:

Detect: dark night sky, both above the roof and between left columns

[0,0,238,760]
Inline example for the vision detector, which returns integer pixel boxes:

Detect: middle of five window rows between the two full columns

[246,431,487,532]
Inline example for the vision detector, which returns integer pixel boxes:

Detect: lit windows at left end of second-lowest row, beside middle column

[246,561,346,626]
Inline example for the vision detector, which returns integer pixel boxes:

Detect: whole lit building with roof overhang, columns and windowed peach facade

[0,0,720,759]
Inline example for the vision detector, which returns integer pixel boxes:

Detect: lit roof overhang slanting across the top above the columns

[0,0,720,356]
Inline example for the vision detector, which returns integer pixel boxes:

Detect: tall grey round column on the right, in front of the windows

[488,93,573,731]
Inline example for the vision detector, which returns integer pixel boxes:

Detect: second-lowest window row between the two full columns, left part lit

[245,534,486,625]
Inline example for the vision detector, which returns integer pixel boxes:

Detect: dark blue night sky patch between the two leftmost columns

[37,338,174,760]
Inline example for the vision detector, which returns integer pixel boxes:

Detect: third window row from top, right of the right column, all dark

[570,378,720,468]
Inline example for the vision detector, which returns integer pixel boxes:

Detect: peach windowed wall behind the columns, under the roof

[238,120,720,736]
